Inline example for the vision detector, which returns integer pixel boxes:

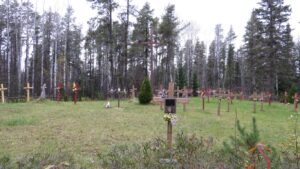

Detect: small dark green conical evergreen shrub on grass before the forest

[139,77,153,104]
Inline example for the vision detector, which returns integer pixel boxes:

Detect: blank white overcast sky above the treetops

[36,0,300,45]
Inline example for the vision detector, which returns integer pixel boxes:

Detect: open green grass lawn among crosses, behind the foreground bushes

[0,98,300,164]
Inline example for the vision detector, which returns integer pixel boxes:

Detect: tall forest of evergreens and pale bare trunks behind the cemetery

[0,0,300,99]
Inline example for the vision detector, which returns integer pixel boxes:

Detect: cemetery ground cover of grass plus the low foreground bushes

[0,98,300,169]
